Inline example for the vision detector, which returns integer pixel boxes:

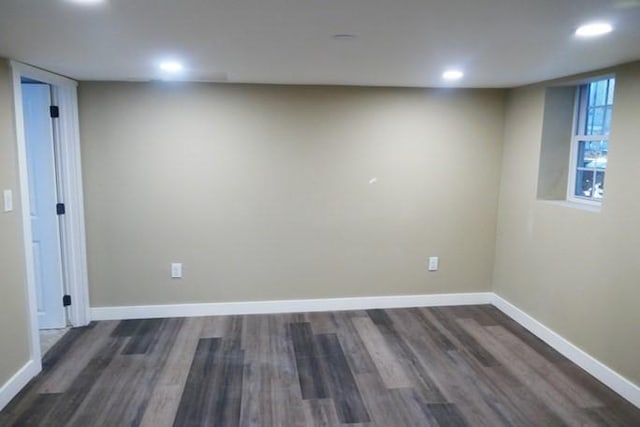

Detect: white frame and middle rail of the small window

[567,75,615,207]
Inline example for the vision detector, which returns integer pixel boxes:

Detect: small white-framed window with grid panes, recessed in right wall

[568,78,615,203]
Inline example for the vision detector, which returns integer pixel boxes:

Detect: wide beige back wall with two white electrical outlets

[79,83,504,306]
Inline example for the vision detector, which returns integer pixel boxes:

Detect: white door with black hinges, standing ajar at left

[22,83,66,329]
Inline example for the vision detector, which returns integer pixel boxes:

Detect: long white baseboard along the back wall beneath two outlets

[91,292,493,320]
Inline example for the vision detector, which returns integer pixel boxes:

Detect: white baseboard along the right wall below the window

[492,294,640,408]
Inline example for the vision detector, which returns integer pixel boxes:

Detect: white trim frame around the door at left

[10,61,91,364]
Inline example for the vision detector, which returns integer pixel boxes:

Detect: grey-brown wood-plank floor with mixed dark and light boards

[0,306,640,427]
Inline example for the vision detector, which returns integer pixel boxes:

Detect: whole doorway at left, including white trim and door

[11,61,90,373]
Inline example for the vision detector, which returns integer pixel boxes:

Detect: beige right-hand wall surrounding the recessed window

[494,63,640,384]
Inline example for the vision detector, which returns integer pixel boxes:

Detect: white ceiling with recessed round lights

[0,0,640,87]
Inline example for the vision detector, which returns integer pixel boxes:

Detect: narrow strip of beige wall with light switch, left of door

[0,58,30,387]
